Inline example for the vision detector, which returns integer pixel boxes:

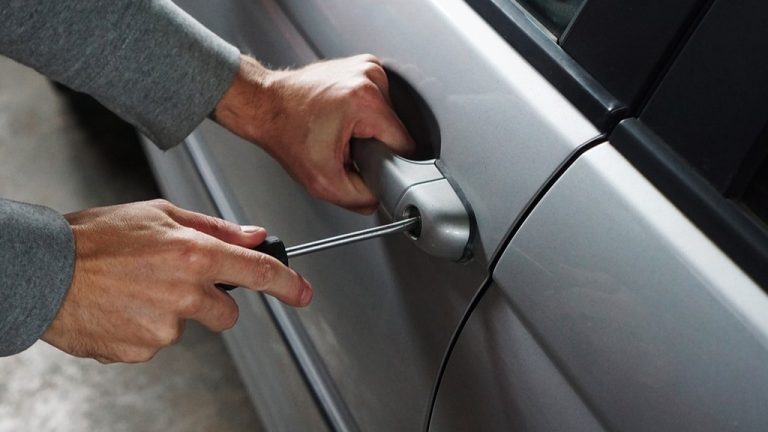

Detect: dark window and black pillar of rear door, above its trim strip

[640,0,768,230]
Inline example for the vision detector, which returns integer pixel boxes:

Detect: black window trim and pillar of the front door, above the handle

[465,0,713,127]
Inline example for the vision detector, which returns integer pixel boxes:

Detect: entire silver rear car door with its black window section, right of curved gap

[429,1,768,431]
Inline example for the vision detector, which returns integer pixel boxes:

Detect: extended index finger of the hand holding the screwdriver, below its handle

[213,243,312,306]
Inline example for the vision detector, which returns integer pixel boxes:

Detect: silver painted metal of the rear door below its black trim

[434,144,768,431]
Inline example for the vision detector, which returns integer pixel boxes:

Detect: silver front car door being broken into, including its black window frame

[147,0,764,430]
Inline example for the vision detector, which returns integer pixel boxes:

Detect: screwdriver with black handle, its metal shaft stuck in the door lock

[216,216,421,291]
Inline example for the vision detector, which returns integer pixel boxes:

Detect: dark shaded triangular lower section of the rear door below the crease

[429,283,604,432]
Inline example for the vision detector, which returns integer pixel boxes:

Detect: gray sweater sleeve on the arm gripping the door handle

[0,0,239,148]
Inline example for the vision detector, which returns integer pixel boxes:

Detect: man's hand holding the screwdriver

[42,200,312,363]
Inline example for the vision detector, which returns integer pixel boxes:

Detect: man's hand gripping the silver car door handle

[214,55,413,213]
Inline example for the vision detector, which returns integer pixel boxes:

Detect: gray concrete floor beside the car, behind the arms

[0,57,262,432]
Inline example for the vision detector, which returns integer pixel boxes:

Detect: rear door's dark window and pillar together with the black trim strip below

[616,0,768,289]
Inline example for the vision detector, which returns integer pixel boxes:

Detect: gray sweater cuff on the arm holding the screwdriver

[0,200,75,356]
